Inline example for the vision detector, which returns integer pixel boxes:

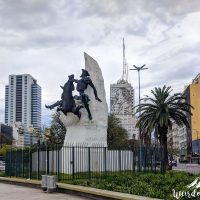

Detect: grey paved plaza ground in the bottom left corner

[0,183,89,200]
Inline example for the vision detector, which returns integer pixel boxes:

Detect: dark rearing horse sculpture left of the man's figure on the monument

[45,74,83,119]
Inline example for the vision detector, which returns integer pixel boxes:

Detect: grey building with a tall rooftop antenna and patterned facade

[110,39,138,139]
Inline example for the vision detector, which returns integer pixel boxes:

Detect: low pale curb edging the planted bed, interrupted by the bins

[0,177,160,200]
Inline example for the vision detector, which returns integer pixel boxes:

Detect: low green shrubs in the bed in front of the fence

[64,171,197,200]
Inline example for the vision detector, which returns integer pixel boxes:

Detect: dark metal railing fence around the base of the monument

[5,145,163,181]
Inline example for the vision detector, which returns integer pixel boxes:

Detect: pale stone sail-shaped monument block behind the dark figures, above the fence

[61,53,108,147]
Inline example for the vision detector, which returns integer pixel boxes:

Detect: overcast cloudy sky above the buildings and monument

[0,0,200,123]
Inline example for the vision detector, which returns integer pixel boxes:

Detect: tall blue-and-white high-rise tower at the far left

[5,74,41,129]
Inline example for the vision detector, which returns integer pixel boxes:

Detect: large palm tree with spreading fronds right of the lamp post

[136,86,192,171]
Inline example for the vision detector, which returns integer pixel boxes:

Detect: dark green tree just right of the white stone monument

[107,114,128,148]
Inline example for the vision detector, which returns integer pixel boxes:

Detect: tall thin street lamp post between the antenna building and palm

[130,64,148,168]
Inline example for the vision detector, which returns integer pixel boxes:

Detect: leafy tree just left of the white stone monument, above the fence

[45,112,66,145]
